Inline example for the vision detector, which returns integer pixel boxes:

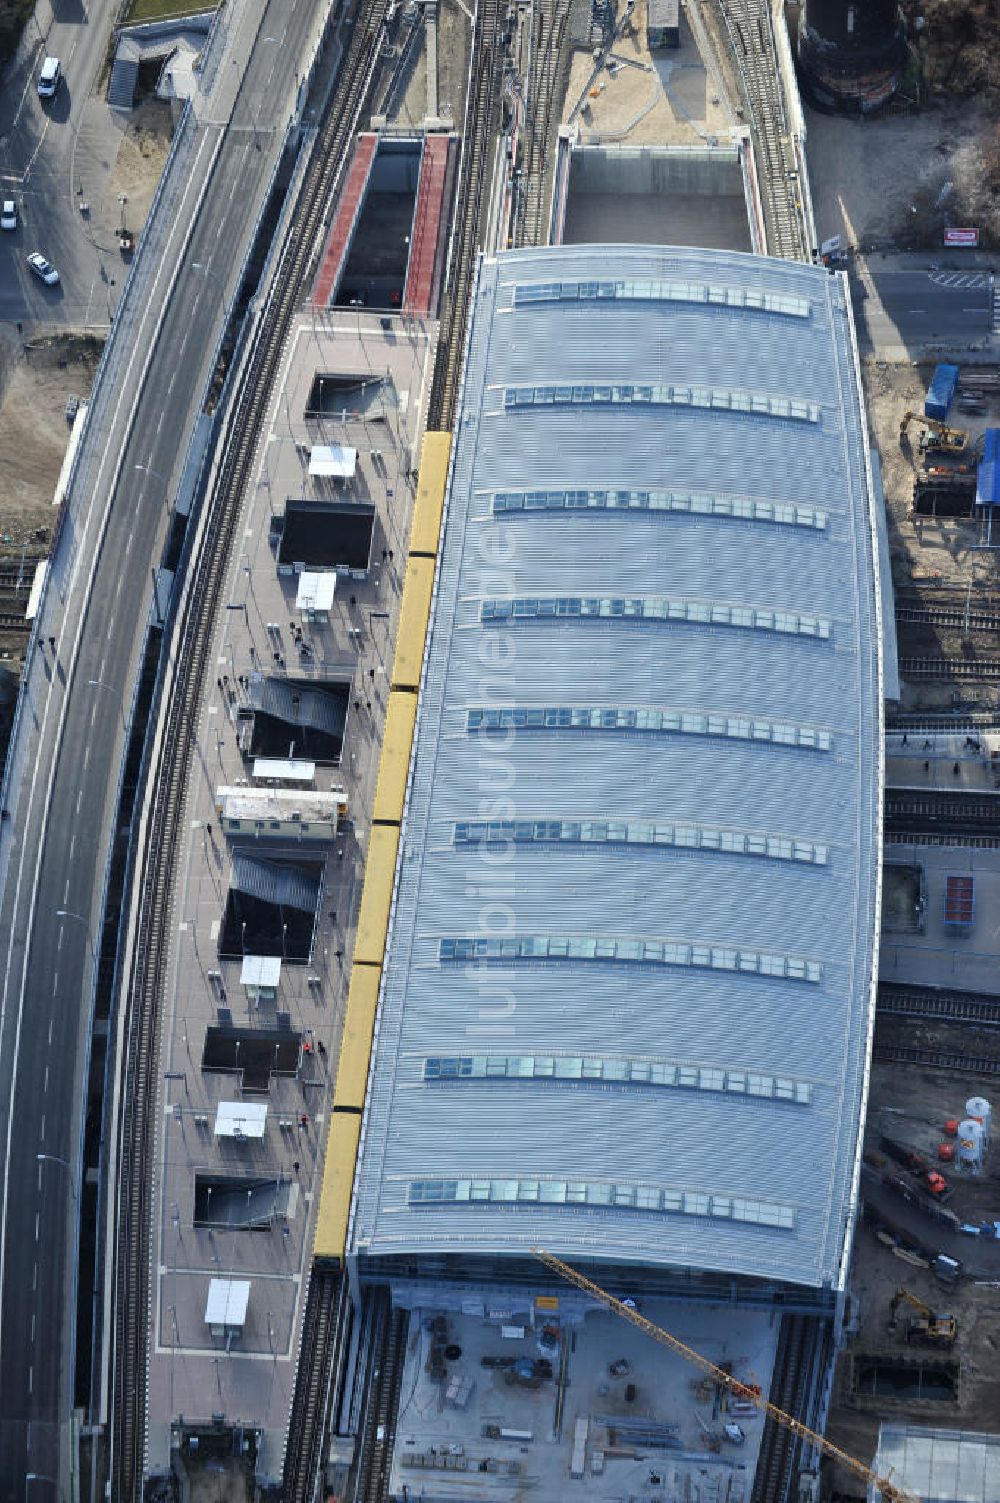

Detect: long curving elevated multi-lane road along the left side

[0,0,319,1484]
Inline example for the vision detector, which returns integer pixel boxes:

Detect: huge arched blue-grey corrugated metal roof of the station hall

[352,246,881,1287]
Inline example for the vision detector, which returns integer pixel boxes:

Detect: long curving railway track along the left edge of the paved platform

[111,0,385,1503]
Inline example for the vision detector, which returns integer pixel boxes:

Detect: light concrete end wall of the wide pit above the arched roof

[570,146,743,198]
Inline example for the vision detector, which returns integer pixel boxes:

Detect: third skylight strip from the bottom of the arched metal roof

[438,933,823,986]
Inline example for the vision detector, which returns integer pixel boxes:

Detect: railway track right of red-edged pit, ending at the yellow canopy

[427,0,504,431]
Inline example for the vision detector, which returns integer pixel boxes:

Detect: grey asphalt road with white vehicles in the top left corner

[0,0,125,326]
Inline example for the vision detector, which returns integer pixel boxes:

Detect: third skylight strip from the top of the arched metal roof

[493,488,829,532]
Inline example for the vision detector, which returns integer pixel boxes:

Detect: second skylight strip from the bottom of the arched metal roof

[424,1054,812,1106]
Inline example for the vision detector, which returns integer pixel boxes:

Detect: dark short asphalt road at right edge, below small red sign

[851,262,992,347]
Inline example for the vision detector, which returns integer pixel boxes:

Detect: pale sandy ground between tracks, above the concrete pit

[565,0,731,146]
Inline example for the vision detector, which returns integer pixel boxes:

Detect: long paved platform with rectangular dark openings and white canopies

[149,310,435,1480]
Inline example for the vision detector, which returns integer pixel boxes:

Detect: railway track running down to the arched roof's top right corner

[714,0,812,262]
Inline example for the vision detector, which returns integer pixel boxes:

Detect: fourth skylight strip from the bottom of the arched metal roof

[453,819,830,866]
